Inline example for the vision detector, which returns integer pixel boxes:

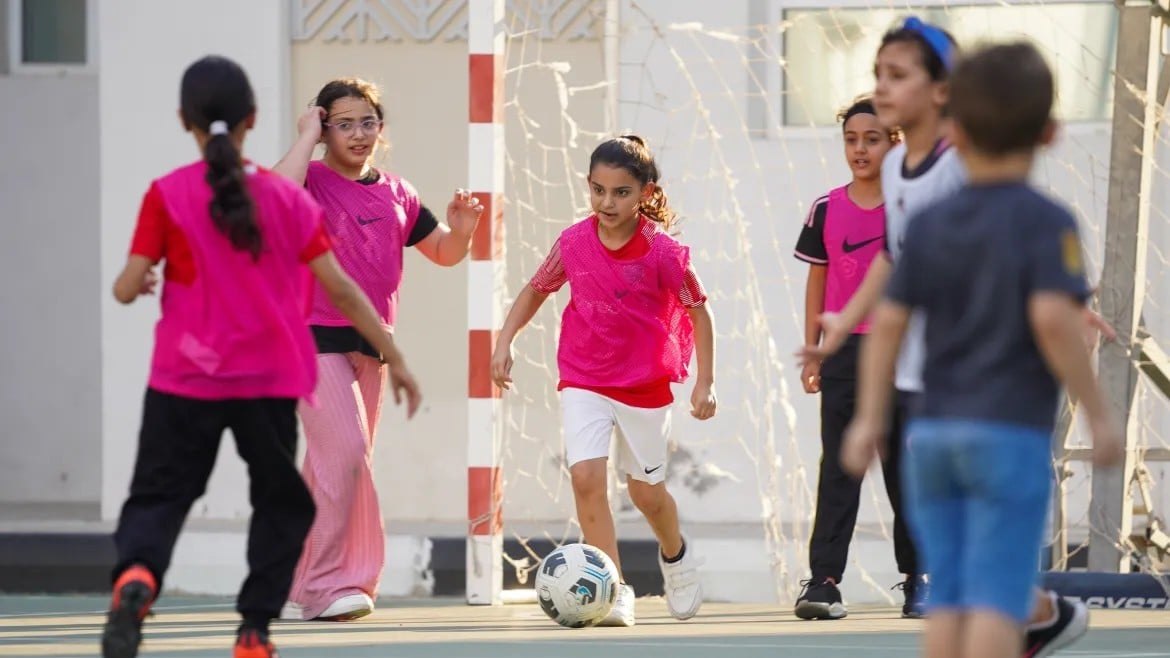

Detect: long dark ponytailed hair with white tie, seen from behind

[179,55,262,259]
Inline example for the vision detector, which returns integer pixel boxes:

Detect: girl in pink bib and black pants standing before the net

[796,98,917,619]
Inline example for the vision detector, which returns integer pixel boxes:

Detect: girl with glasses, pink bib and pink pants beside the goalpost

[274,78,483,621]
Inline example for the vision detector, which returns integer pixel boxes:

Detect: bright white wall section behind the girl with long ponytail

[95,0,289,519]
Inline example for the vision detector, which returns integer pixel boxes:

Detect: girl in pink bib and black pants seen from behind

[102,57,420,658]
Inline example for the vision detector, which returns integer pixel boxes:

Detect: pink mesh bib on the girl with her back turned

[150,162,322,399]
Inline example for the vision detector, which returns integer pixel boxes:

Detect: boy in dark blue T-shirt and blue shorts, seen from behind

[841,43,1122,658]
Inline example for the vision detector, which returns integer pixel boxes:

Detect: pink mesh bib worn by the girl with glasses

[305,160,420,330]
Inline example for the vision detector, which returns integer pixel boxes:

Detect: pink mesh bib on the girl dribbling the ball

[557,220,695,388]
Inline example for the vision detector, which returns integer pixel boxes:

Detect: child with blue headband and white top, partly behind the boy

[801,18,1090,658]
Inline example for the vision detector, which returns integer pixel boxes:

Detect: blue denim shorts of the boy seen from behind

[902,418,1052,624]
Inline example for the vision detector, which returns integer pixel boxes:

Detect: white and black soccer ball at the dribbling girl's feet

[536,543,619,629]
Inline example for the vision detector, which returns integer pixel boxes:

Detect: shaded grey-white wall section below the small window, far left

[0,71,104,503]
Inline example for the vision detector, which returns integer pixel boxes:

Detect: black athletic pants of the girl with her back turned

[113,389,316,625]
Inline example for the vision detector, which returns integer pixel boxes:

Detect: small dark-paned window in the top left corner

[7,0,97,73]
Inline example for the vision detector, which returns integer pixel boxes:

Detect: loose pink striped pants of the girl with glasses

[289,352,386,619]
